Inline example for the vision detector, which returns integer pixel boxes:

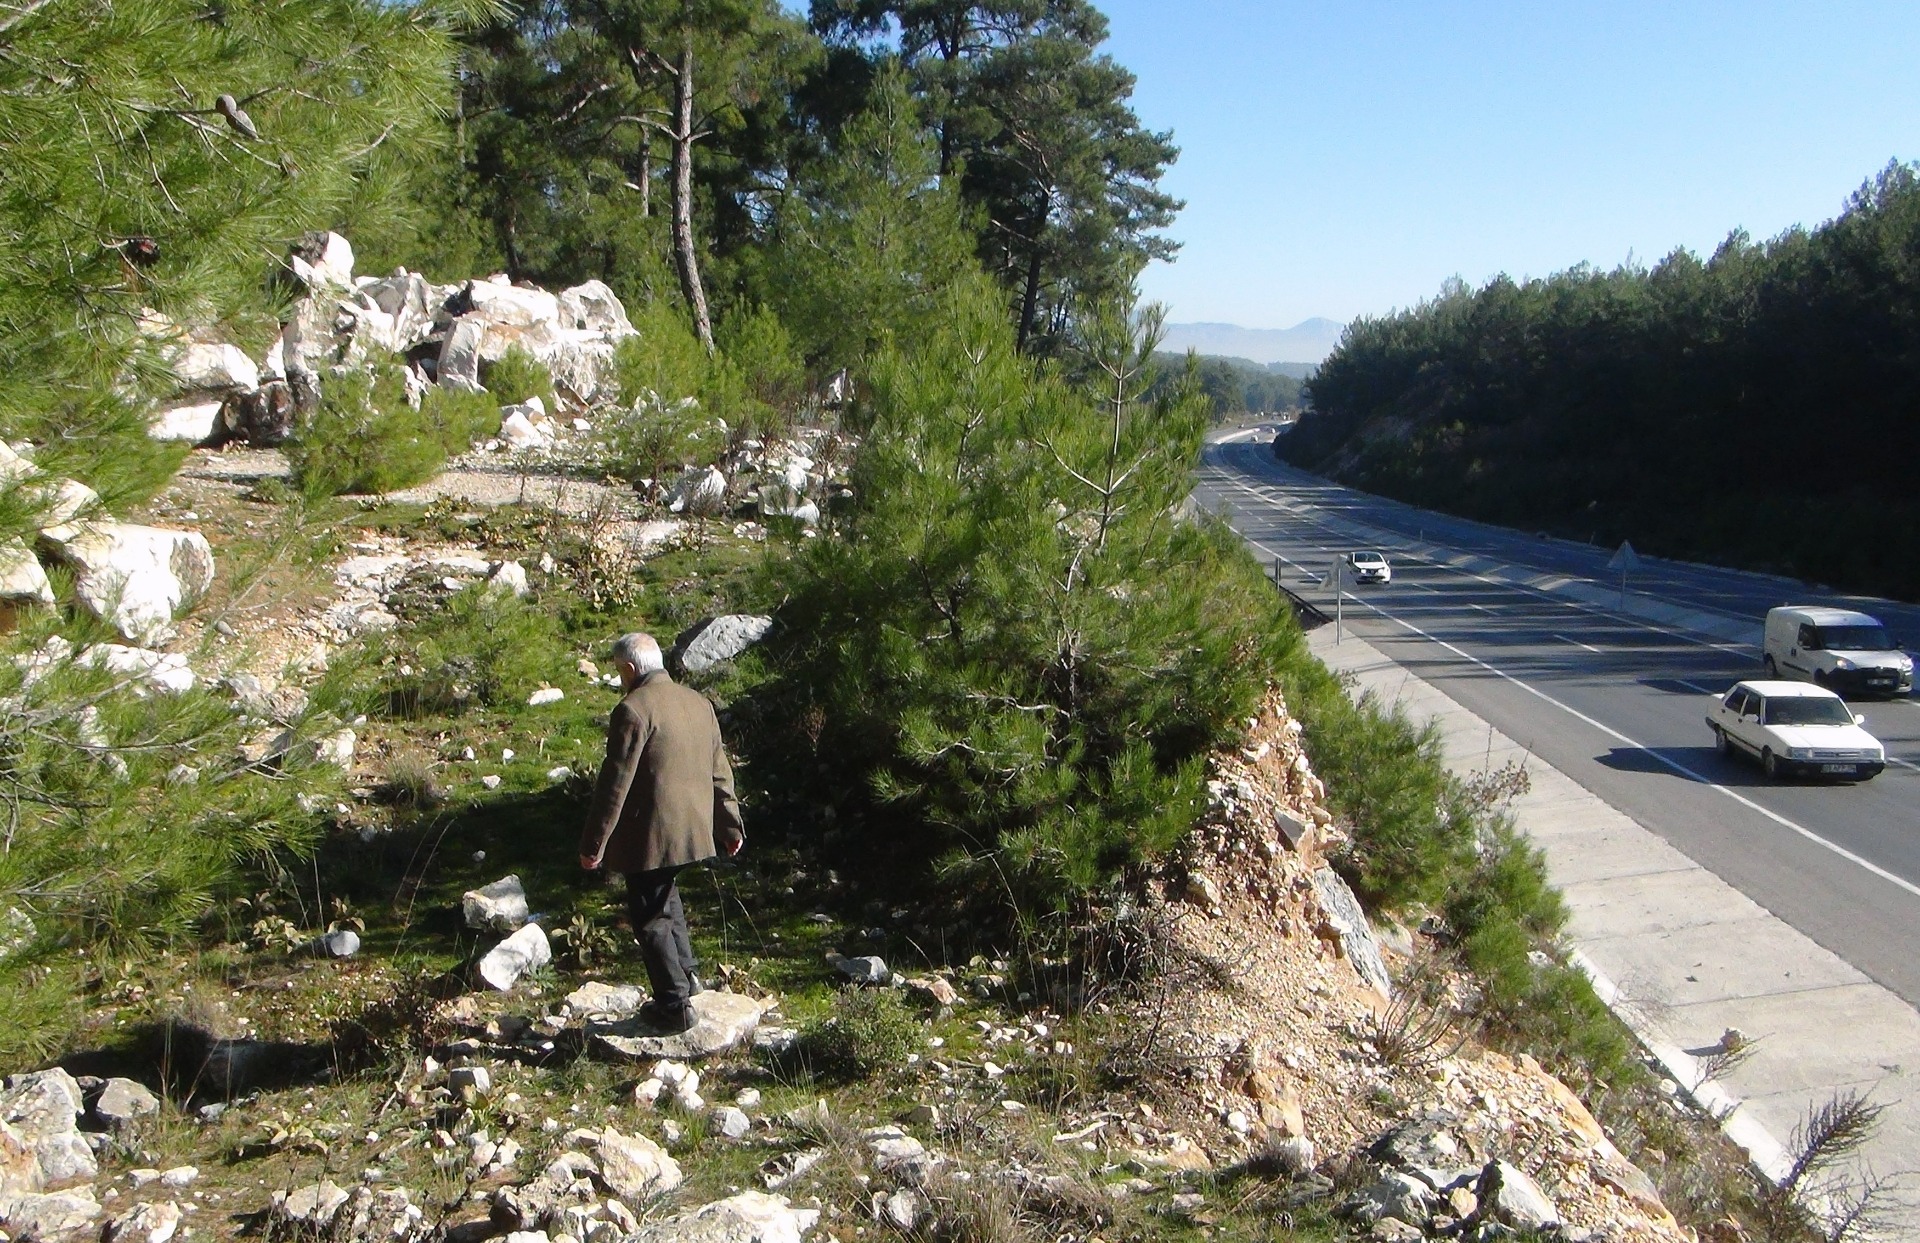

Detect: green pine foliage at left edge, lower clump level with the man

[0,619,342,1064]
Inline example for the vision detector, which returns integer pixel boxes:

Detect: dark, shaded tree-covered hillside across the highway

[1281,165,1920,599]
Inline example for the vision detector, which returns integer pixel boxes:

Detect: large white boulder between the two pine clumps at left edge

[60,521,213,646]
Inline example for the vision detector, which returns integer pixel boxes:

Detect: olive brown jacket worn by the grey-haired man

[580,669,745,872]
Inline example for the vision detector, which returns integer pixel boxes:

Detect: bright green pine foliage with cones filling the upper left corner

[0,0,484,500]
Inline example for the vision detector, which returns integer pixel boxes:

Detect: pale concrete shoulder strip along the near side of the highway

[1309,628,1920,1198]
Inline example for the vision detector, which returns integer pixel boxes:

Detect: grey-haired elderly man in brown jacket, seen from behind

[580,634,747,1032]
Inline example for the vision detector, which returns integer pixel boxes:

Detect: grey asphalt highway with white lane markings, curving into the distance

[1196,442,1920,1005]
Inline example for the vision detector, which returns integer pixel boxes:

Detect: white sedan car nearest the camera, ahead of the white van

[1707,682,1887,782]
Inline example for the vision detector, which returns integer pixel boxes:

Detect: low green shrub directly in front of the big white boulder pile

[286,363,499,498]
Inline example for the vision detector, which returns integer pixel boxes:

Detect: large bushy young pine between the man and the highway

[741,288,1300,913]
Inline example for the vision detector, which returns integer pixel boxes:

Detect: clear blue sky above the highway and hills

[1096,0,1920,329]
